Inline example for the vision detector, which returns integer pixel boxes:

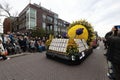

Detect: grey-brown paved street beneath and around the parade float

[0,42,109,80]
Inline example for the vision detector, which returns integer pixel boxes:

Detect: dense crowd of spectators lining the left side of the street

[1,32,47,55]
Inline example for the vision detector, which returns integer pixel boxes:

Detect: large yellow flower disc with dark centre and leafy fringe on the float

[67,20,95,45]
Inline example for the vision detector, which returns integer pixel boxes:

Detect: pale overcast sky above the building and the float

[0,0,120,36]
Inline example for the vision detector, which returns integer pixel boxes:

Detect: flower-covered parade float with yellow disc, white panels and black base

[46,20,95,62]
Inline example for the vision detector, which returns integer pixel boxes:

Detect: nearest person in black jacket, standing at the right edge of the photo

[106,27,120,80]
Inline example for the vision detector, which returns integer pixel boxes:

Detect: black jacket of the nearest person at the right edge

[106,36,120,64]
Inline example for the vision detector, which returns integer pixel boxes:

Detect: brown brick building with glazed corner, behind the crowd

[8,4,69,35]
